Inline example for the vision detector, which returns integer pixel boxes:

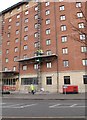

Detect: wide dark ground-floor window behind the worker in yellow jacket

[21,77,38,85]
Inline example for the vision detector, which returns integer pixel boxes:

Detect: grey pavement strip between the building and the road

[2,91,87,100]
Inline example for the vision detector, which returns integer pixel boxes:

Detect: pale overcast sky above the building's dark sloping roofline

[0,0,21,12]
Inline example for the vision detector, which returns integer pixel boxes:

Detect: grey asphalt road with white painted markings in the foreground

[0,99,87,118]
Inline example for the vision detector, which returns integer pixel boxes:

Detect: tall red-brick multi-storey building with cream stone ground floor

[0,1,87,92]
